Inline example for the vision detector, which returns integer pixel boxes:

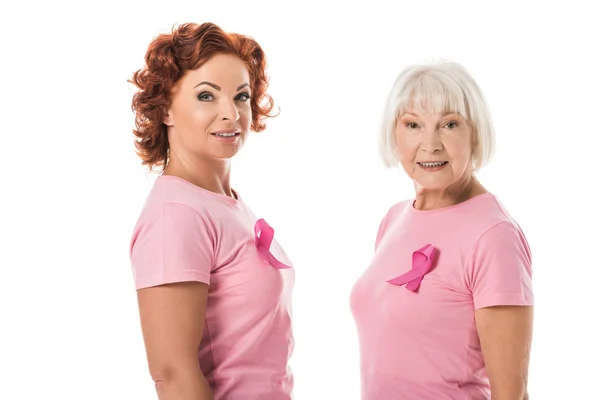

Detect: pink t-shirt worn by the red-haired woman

[131,175,294,400]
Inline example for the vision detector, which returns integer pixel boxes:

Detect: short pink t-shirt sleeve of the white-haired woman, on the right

[467,221,533,310]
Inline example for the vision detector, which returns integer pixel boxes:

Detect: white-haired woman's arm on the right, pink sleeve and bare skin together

[467,222,533,400]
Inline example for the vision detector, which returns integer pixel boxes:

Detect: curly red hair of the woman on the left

[129,22,274,169]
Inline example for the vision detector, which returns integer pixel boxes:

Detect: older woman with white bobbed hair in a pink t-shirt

[351,62,533,400]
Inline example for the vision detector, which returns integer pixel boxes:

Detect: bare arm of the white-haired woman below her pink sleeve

[475,306,533,400]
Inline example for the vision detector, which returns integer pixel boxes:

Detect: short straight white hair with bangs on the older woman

[379,60,495,171]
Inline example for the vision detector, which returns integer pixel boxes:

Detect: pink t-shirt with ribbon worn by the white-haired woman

[350,193,533,400]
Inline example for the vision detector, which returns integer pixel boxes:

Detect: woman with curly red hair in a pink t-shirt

[130,23,294,400]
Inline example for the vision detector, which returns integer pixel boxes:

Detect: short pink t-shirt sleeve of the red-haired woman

[130,203,215,289]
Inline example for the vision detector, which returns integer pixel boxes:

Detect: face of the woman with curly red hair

[164,54,252,160]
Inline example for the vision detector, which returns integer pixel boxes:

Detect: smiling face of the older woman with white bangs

[396,110,473,190]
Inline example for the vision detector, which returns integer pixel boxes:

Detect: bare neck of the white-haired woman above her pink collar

[414,174,487,210]
